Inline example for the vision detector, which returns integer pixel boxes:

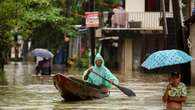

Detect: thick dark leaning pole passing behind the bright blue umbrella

[172,0,191,85]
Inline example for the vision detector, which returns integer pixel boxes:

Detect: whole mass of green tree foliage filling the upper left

[0,0,120,70]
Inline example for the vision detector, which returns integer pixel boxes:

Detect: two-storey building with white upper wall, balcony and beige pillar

[102,0,174,74]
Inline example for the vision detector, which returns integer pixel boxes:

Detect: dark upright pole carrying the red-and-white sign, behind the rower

[89,0,95,65]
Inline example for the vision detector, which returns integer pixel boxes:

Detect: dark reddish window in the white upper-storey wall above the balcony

[145,0,169,12]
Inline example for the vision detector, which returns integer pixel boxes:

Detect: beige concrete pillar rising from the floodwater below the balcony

[121,38,133,76]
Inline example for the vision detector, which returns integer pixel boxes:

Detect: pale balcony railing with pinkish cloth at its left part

[102,12,173,30]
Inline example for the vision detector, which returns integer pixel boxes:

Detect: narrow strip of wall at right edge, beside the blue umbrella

[190,23,195,85]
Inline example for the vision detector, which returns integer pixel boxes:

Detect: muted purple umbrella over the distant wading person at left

[31,48,54,58]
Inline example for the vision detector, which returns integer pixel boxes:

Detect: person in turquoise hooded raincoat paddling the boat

[83,53,119,89]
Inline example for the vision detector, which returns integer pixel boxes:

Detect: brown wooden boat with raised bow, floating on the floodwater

[53,73,109,101]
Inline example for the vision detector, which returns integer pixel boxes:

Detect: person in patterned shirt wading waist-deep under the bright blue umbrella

[162,72,187,110]
